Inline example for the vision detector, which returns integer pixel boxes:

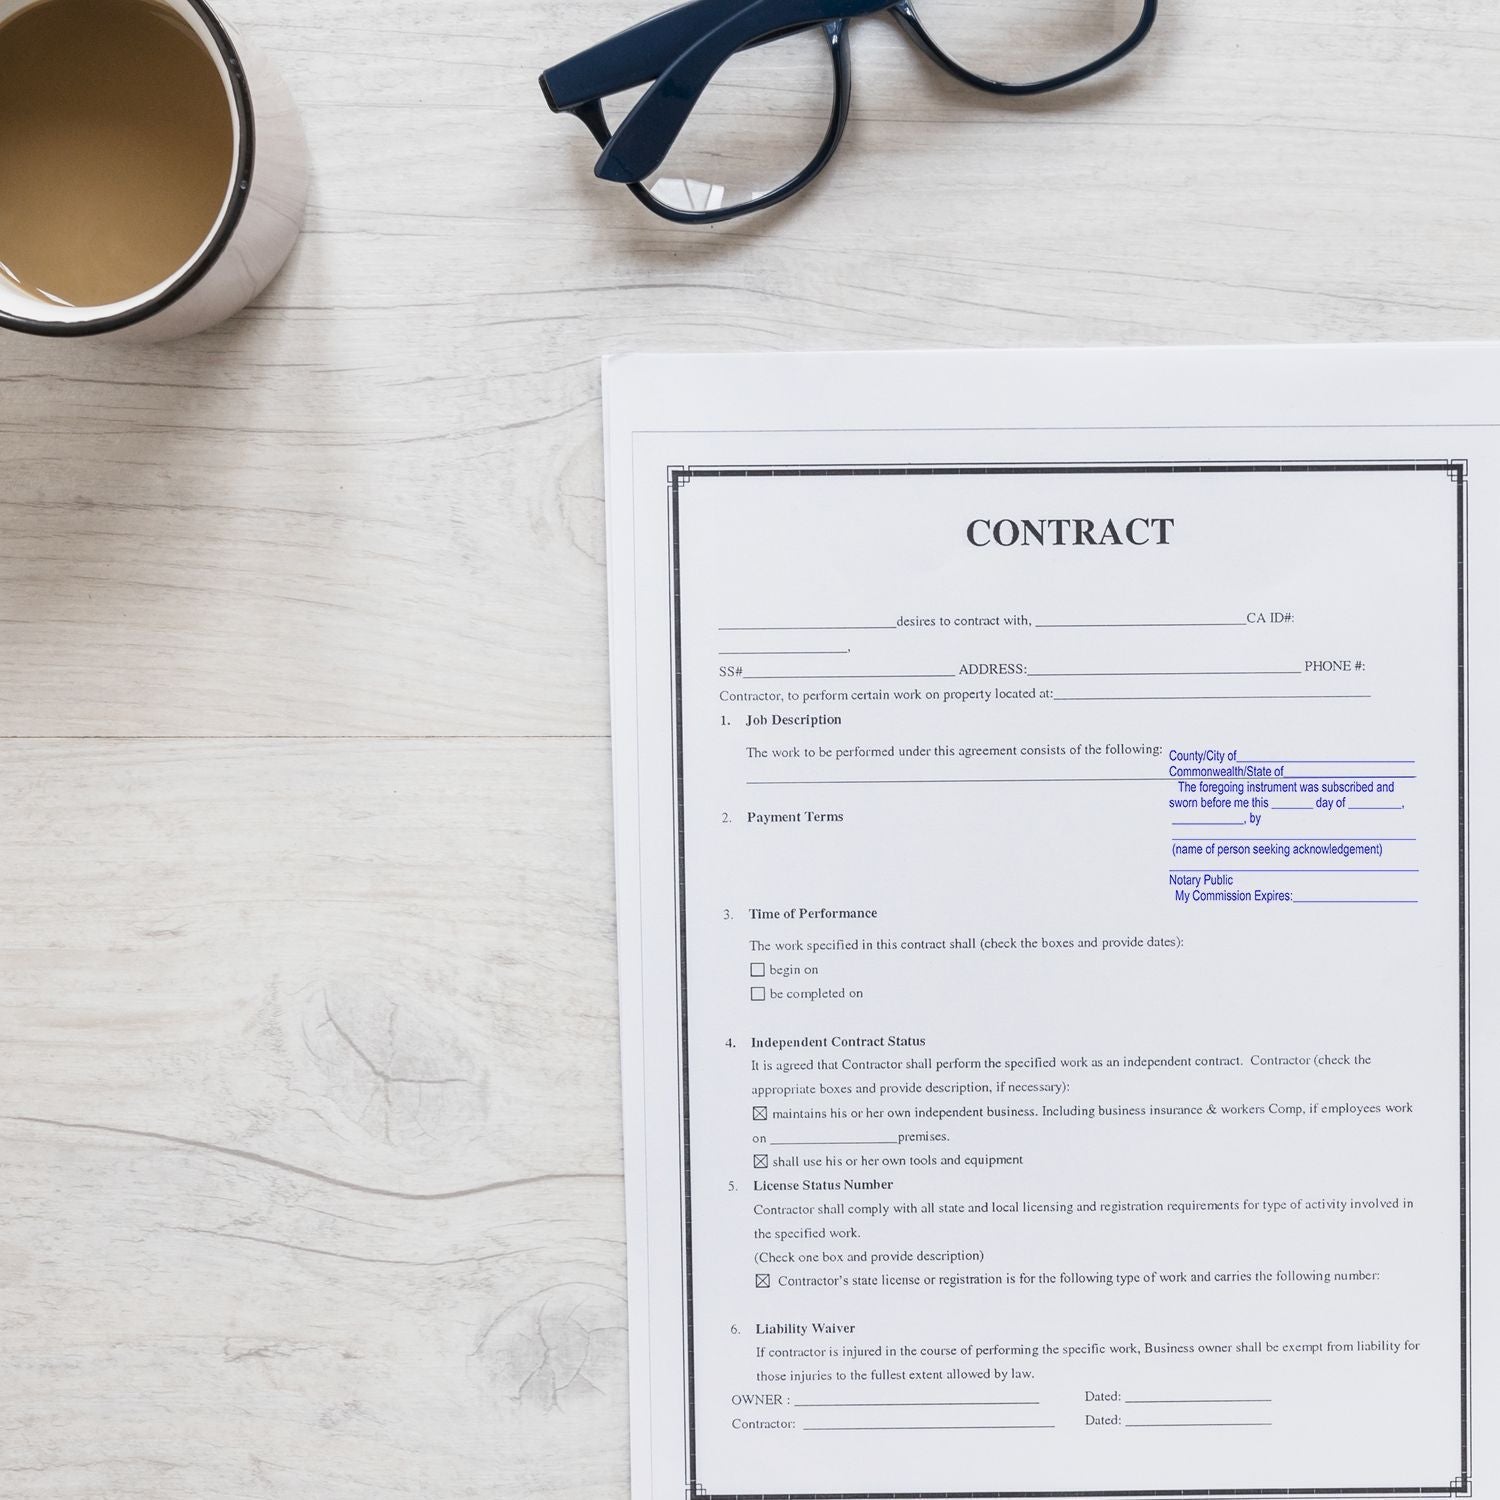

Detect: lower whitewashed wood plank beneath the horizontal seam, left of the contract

[0,741,626,1500]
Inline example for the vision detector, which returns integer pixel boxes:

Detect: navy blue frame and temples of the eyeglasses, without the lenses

[539,0,1157,224]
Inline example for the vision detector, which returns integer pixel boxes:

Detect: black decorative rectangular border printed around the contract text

[668,459,1473,1500]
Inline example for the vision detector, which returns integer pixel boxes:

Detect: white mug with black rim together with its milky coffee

[0,0,306,338]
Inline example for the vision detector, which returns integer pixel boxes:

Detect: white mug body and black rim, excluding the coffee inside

[0,0,308,342]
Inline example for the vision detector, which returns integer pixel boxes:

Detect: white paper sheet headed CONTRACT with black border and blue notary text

[606,347,1500,1500]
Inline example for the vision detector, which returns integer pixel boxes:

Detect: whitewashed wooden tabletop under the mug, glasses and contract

[0,0,1500,1500]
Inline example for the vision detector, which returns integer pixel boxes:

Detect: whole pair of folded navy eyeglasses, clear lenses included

[540,0,1157,224]
